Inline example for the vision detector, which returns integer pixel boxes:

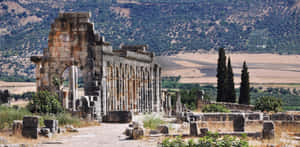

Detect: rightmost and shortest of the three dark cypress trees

[239,61,250,105]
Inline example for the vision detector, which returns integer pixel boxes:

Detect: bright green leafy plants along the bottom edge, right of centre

[161,132,249,147]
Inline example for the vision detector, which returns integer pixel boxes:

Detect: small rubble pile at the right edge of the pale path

[124,122,144,139]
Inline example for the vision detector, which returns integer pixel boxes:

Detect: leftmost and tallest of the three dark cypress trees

[217,48,226,102]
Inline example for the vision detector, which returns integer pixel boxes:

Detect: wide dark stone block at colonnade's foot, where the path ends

[103,111,132,123]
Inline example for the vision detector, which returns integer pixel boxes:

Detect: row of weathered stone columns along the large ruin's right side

[102,64,160,112]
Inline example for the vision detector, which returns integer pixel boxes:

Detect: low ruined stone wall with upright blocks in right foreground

[183,112,300,139]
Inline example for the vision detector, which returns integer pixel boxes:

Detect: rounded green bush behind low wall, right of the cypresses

[255,96,282,112]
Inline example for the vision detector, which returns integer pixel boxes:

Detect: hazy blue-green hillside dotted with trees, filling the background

[0,0,300,79]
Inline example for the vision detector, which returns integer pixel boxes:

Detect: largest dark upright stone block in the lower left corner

[22,116,39,139]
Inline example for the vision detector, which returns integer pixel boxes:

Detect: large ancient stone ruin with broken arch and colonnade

[31,13,162,120]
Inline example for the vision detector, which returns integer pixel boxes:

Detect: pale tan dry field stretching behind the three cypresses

[158,53,300,87]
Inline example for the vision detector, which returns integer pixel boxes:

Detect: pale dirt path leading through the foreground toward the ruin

[41,123,157,147]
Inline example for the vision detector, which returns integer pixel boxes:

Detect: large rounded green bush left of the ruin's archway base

[28,91,63,114]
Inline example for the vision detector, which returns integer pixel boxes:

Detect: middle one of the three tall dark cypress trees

[225,57,236,103]
